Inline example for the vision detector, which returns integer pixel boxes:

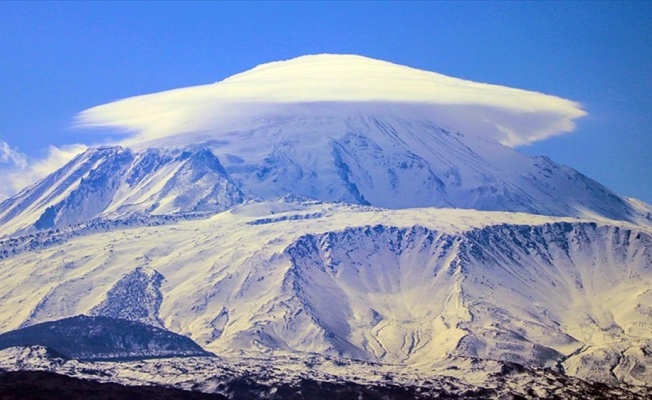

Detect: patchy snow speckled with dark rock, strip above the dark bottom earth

[0,346,650,399]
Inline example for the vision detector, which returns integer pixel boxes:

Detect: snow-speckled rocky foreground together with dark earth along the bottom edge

[0,347,652,400]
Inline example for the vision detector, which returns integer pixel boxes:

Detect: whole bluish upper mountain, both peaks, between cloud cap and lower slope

[0,111,652,234]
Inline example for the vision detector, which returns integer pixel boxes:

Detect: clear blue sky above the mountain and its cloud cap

[0,1,652,203]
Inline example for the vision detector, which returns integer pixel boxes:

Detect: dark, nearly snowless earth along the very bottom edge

[0,371,646,400]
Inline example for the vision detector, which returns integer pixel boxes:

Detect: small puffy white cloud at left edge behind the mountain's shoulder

[0,141,87,200]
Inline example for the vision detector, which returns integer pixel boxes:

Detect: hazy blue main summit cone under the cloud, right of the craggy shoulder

[194,108,652,223]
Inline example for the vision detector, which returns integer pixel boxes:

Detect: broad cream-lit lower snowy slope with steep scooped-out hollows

[0,200,652,384]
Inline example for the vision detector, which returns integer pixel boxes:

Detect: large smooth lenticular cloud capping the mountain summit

[77,54,586,147]
